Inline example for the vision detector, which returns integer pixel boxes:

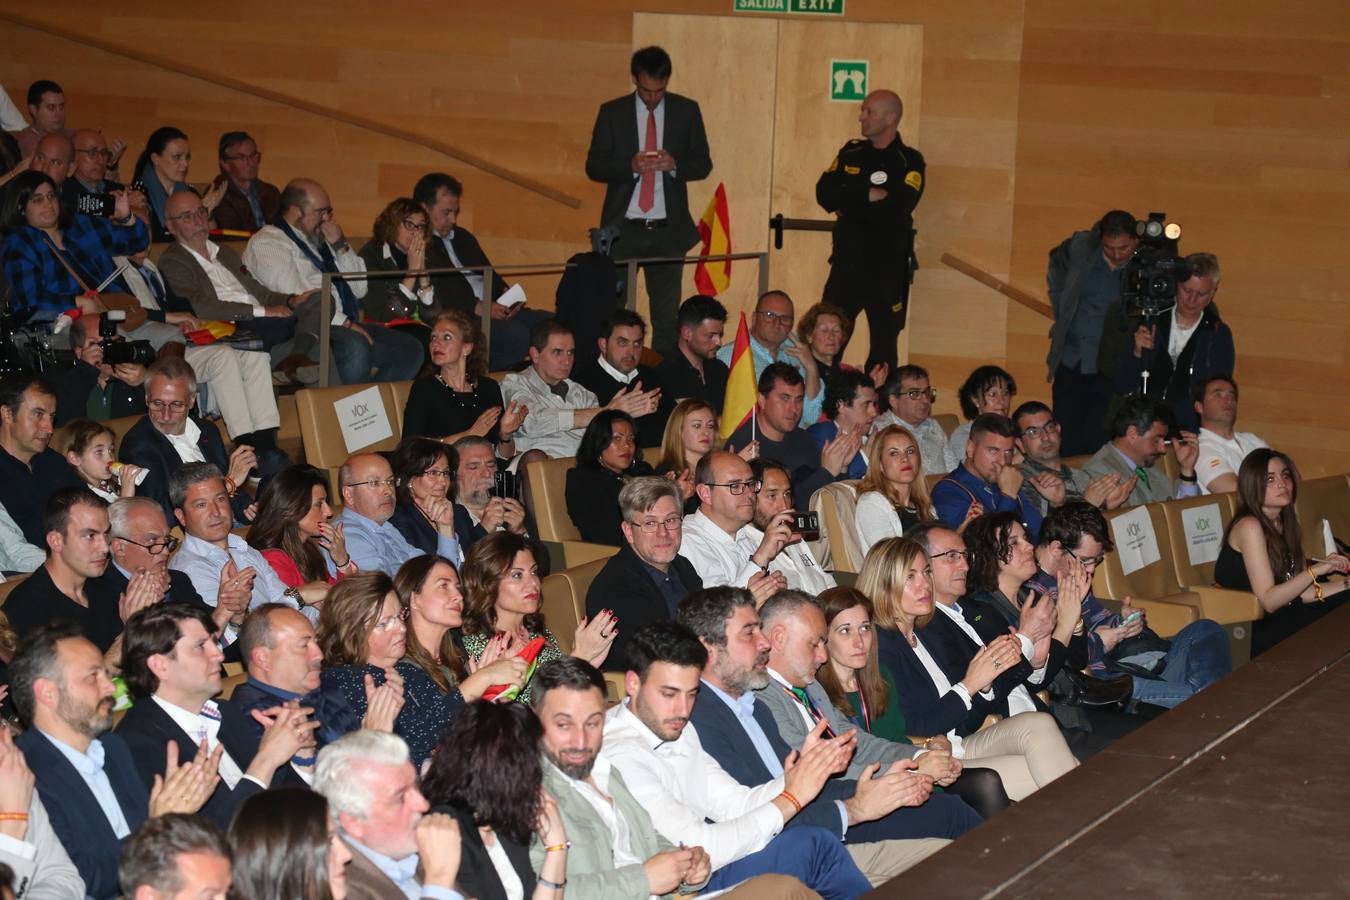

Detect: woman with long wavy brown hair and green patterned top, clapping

[460,532,620,703]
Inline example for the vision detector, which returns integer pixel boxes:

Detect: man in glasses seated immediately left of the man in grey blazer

[1013,399,1134,515]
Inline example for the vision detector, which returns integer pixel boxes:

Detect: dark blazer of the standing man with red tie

[586,93,713,248]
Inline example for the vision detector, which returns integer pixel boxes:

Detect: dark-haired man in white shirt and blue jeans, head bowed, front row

[601,622,871,897]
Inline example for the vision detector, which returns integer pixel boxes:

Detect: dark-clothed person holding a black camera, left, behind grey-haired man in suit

[51,316,146,428]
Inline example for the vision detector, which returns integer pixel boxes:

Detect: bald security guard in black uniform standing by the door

[815,90,923,371]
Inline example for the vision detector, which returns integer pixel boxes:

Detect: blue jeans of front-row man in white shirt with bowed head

[705,826,872,900]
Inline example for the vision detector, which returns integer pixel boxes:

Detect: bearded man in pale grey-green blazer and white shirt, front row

[529,656,818,900]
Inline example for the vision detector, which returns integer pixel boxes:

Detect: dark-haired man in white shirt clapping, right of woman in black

[502,318,660,461]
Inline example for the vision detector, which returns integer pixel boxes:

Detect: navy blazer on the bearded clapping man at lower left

[15,729,146,900]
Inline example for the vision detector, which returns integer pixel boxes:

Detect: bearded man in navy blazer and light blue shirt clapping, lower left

[9,622,220,900]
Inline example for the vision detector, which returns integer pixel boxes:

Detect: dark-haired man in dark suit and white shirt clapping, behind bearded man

[115,603,319,827]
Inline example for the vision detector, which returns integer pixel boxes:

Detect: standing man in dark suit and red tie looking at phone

[586,47,713,355]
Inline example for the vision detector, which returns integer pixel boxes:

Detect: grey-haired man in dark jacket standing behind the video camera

[1098,254,1235,432]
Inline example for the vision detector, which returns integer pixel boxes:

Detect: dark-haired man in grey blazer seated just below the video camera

[1083,397,1200,507]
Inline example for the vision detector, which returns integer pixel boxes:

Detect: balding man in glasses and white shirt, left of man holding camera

[679,451,798,603]
